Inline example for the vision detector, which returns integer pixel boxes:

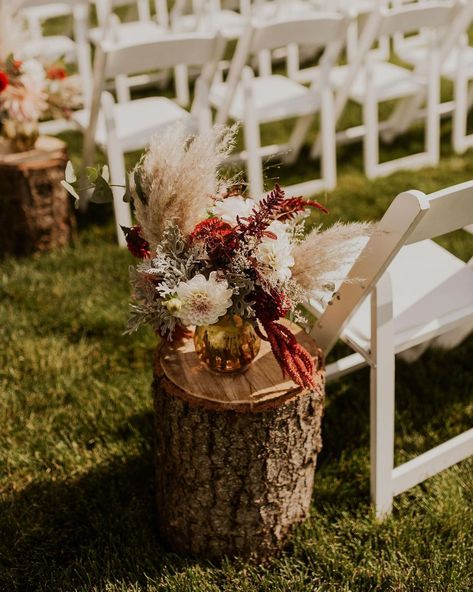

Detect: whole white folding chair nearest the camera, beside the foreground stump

[309,181,473,517]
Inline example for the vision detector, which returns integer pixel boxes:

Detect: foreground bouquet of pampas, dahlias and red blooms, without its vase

[64,126,370,388]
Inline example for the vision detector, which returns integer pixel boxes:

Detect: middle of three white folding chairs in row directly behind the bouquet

[209,13,348,196]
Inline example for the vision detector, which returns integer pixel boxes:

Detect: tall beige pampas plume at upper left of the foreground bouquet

[132,123,236,248]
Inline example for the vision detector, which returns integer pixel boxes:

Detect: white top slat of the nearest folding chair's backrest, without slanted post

[407,181,473,243]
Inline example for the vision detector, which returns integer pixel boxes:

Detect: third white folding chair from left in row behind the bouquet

[313,0,455,178]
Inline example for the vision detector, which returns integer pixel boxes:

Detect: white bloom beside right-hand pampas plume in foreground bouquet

[256,220,294,282]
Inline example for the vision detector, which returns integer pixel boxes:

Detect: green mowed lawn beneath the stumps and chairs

[0,81,473,592]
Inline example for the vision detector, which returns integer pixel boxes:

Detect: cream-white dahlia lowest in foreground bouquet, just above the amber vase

[174,271,233,326]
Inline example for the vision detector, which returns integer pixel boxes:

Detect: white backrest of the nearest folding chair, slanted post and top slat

[312,181,473,352]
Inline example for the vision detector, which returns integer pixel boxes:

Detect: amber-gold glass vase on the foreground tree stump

[194,315,261,372]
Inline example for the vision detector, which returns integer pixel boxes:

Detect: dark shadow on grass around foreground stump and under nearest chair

[0,339,473,592]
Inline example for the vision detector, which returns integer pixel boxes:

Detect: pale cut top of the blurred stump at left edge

[0,136,66,169]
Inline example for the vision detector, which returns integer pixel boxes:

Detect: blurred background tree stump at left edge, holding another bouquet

[0,136,75,255]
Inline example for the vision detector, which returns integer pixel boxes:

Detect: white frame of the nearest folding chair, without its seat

[309,181,473,517]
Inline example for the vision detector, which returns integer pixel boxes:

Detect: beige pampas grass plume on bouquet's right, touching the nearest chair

[292,222,375,297]
